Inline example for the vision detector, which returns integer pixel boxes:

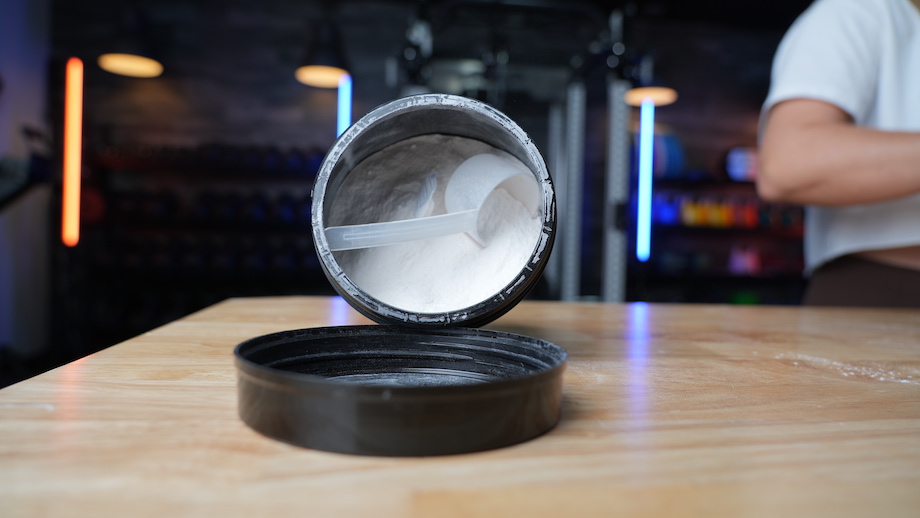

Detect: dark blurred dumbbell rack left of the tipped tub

[59,145,334,351]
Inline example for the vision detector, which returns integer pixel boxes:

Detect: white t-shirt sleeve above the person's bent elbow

[763,0,881,122]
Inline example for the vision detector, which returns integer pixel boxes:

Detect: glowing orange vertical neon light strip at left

[61,58,83,246]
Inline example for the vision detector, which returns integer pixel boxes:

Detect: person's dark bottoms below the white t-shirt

[802,255,920,308]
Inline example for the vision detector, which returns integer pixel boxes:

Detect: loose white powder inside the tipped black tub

[330,136,542,313]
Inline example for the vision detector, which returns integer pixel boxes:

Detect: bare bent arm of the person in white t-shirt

[757,99,920,206]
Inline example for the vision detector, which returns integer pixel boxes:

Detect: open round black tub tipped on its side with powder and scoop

[312,94,555,327]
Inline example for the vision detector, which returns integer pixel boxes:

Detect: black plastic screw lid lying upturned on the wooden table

[235,326,567,456]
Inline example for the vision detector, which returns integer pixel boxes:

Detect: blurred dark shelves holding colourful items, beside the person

[628,179,804,304]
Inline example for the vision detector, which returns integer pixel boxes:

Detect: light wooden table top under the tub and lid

[0,297,920,517]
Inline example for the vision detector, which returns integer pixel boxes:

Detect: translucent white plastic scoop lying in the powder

[326,153,540,252]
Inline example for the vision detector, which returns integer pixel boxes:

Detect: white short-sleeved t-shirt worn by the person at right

[762,0,920,271]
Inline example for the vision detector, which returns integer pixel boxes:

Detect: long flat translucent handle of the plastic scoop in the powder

[326,209,479,252]
